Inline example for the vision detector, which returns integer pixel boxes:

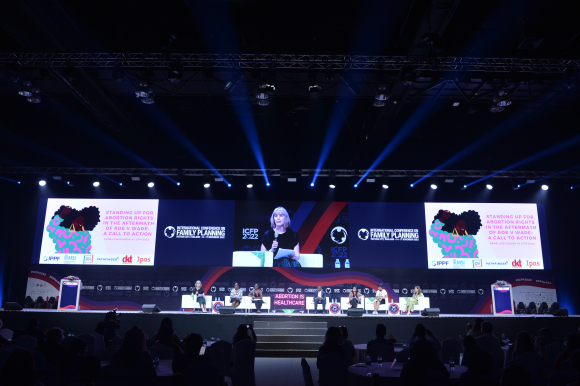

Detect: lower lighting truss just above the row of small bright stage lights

[0,167,580,180]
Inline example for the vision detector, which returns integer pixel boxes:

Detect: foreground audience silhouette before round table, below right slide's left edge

[401,332,449,385]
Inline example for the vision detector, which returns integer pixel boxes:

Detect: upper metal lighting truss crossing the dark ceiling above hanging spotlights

[0,52,580,74]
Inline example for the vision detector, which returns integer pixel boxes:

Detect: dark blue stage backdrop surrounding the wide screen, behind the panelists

[0,181,580,313]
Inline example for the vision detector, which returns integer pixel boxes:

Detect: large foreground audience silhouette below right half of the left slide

[111,326,157,385]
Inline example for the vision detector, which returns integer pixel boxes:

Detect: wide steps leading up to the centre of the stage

[254,320,327,358]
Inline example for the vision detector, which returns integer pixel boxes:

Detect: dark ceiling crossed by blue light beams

[0,0,580,176]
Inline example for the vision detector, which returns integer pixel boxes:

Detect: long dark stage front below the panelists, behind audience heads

[0,309,580,358]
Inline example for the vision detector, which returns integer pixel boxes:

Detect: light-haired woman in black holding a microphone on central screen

[261,206,301,267]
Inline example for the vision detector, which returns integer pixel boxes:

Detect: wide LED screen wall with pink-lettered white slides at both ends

[32,198,551,270]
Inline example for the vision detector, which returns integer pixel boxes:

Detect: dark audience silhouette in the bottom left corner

[0,348,42,386]
